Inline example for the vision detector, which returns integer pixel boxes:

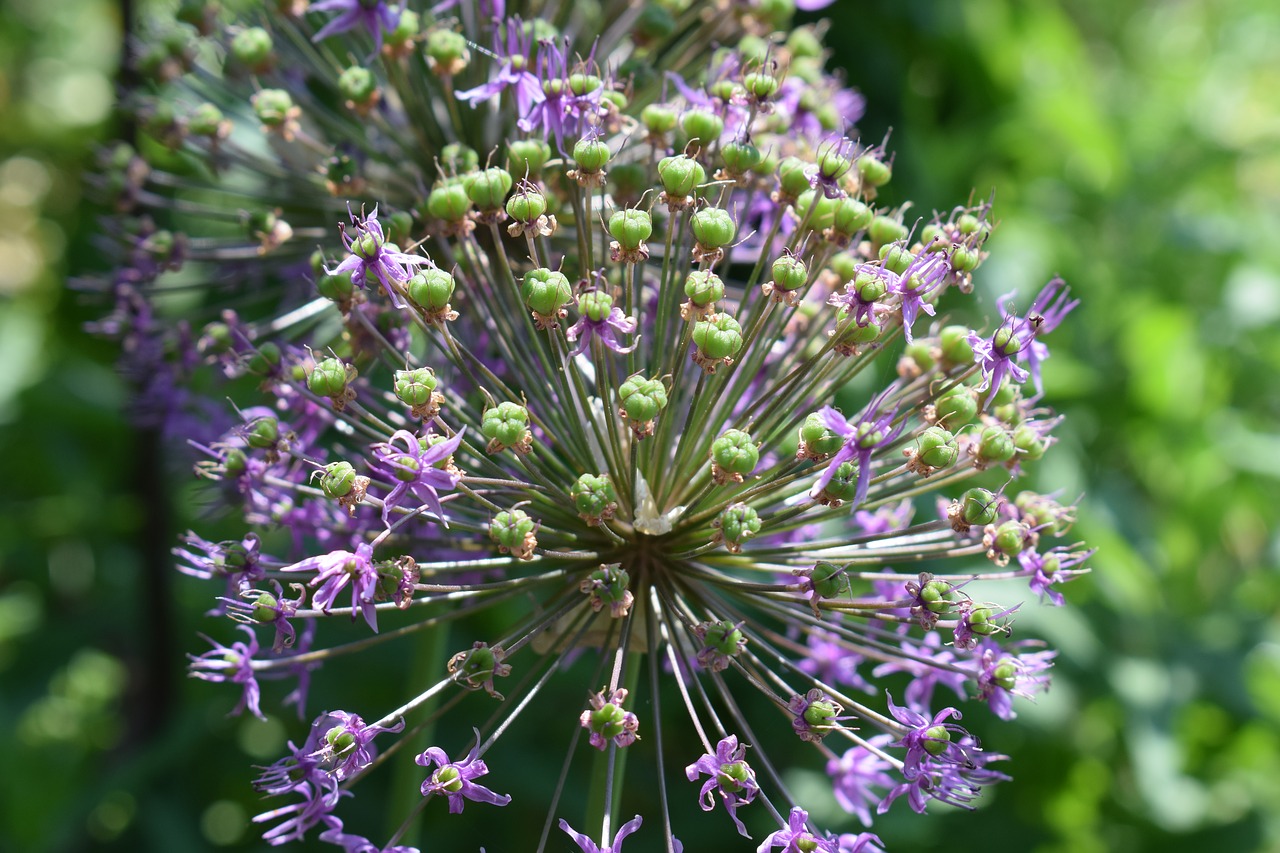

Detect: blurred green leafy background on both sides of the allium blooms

[0,0,1280,853]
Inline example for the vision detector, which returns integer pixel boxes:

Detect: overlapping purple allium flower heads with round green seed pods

[90,0,1092,853]
